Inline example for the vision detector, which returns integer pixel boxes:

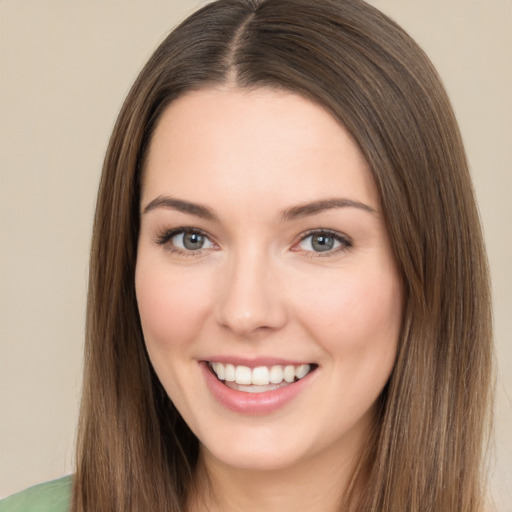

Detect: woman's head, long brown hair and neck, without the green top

[2,0,492,512]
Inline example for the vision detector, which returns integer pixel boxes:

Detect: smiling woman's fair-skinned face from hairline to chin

[136,87,402,469]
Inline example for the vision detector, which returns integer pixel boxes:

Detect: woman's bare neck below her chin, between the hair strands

[187,432,370,512]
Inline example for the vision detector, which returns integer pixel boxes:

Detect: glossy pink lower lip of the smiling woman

[200,361,316,415]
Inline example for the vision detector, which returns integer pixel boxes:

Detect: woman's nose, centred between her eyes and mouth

[216,247,288,338]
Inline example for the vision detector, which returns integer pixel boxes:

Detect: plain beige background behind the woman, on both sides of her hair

[0,0,512,512]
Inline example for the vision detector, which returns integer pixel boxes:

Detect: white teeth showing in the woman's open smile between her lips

[208,361,318,393]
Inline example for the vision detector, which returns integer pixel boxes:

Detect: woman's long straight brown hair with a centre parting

[73,0,492,512]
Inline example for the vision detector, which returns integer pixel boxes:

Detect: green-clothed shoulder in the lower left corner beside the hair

[0,475,73,512]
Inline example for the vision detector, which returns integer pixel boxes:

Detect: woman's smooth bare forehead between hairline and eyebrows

[143,87,378,211]
